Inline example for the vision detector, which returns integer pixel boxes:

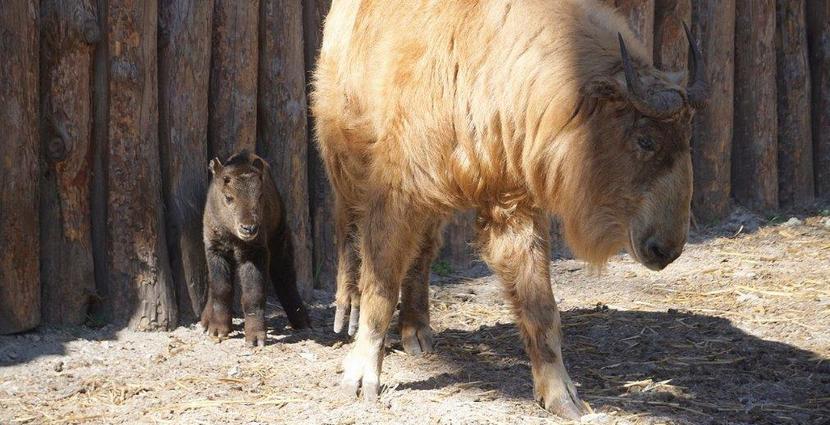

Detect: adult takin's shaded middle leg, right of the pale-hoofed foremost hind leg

[399,221,441,355]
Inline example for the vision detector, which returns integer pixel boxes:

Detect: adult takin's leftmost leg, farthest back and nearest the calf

[334,194,360,335]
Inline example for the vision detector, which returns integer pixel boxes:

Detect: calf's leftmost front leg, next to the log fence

[202,247,233,341]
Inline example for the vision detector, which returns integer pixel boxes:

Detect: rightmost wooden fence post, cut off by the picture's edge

[807,0,830,197]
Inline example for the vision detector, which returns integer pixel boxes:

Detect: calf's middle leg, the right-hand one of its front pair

[236,248,268,347]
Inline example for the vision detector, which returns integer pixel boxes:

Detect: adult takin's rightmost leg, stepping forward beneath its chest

[479,209,584,419]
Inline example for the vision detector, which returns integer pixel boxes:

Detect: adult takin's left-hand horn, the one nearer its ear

[617,33,685,119]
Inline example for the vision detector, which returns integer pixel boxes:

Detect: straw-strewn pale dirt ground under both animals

[0,212,830,424]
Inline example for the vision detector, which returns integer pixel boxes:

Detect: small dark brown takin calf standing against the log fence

[202,151,309,346]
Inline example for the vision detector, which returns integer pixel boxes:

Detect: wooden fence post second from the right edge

[775,0,815,206]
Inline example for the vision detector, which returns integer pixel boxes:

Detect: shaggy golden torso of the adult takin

[312,0,649,208]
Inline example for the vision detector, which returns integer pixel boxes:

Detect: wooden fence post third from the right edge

[736,0,778,210]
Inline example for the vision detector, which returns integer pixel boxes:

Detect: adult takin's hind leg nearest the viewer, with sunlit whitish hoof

[341,194,422,400]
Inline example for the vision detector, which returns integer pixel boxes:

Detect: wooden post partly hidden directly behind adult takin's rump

[303,0,337,288]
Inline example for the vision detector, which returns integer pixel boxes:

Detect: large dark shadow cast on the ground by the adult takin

[398,307,830,424]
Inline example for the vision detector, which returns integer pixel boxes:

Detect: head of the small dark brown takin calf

[209,152,266,241]
